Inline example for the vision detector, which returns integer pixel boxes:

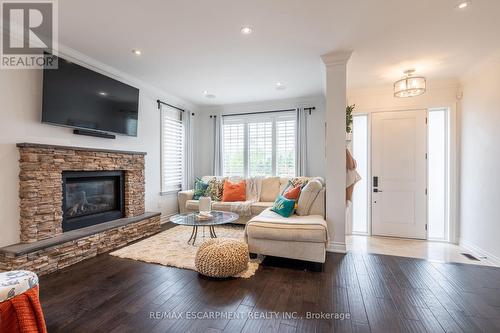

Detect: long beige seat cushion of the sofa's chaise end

[245,209,328,243]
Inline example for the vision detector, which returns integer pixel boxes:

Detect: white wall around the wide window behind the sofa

[195,96,325,177]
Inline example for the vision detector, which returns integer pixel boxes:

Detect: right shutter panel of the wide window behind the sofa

[276,116,296,177]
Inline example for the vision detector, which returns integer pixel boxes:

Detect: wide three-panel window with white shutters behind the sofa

[222,111,296,177]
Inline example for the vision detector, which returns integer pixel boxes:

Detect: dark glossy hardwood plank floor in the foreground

[40,240,500,333]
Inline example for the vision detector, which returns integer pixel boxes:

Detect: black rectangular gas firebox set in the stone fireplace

[62,171,125,232]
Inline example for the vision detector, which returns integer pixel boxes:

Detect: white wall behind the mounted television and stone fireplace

[0,51,193,246]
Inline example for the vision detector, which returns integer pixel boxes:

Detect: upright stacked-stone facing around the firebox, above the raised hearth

[17,143,145,243]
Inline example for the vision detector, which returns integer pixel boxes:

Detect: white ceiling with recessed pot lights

[59,0,500,105]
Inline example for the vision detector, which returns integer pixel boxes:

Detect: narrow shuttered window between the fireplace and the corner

[161,105,184,193]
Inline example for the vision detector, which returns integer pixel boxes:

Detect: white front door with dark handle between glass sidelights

[372,110,427,239]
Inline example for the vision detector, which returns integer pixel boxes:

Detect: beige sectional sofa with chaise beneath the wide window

[178,176,328,263]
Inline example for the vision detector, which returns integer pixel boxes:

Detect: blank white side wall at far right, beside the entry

[460,56,500,263]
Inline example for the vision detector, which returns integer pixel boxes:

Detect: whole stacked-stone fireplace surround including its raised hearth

[0,143,160,274]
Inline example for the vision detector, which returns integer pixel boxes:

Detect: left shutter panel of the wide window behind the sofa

[222,123,245,177]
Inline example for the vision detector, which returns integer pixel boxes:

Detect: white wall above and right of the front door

[348,80,459,243]
